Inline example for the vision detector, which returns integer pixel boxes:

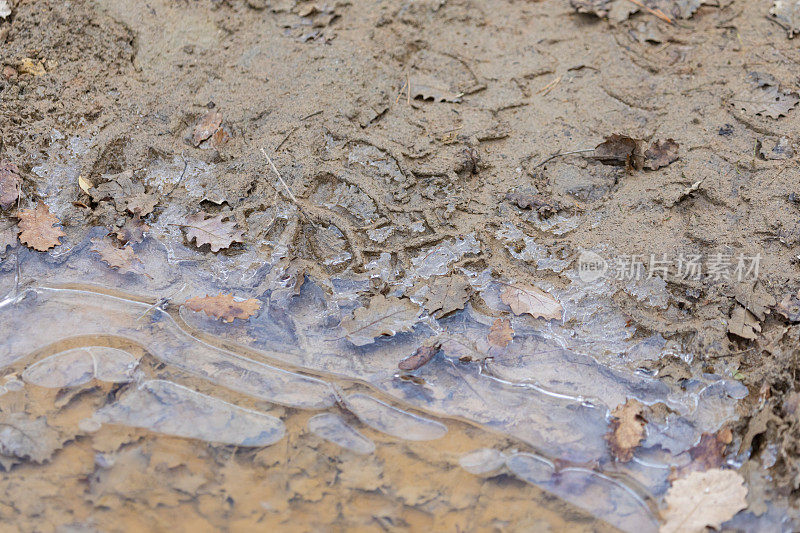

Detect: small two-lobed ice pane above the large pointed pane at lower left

[22,346,139,388]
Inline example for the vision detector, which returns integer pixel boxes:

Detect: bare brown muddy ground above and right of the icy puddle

[0,0,800,527]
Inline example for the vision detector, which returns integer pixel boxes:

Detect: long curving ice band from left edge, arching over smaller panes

[0,289,336,409]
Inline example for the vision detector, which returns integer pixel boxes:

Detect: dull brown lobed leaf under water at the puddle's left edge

[0,413,63,463]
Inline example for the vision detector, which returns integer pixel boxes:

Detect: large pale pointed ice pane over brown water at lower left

[94,380,285,446]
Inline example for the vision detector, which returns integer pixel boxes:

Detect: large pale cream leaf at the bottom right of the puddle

[659,468,747,533]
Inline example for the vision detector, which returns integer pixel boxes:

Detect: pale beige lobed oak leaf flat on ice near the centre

[342,294,420,346]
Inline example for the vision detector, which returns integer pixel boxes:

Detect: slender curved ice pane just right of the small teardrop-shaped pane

[345,393,447,440]
